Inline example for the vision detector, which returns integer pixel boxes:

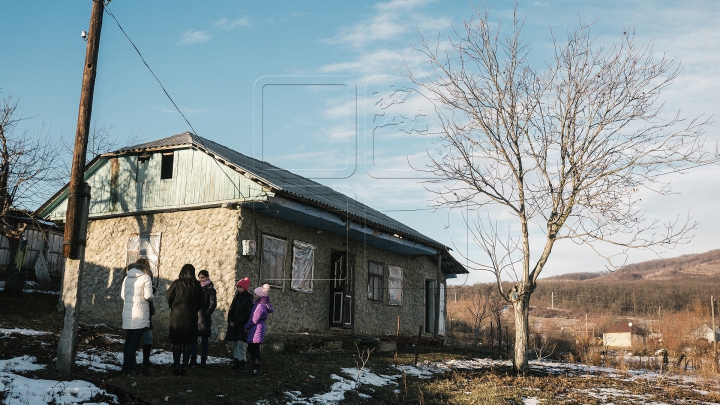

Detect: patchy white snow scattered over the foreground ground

[0,285,719,405]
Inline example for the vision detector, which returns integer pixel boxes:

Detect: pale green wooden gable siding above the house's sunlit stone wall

[41,148,264,220]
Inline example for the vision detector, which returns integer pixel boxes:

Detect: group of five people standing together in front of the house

[120,258,274,375]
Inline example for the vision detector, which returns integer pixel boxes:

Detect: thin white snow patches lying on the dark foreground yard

[0,322,713,405]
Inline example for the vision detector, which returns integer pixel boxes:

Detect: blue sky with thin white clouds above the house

[0,0,720,283]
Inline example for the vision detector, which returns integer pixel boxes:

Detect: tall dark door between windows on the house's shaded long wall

[330,252,355,329]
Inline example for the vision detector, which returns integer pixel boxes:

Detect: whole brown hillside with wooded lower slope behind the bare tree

[453,250,720,318]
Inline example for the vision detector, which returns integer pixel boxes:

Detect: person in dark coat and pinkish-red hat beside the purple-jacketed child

[225,277,253,371]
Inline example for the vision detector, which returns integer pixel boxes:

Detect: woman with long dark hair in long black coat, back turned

[167,264,204,375]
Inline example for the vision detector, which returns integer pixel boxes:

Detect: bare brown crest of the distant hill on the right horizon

[543,249,720,281]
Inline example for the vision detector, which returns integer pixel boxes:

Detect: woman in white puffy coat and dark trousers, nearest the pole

[120,263,154,371]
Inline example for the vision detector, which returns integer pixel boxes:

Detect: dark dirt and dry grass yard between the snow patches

[0,293,720,405]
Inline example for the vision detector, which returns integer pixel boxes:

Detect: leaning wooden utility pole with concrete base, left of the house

[57,0,105,373]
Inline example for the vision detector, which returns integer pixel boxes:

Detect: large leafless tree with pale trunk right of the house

[407,10,717,371]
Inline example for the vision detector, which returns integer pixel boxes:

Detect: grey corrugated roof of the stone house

[113,132,468,274]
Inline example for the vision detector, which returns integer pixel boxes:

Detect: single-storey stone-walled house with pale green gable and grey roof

[37,132,467,344]
